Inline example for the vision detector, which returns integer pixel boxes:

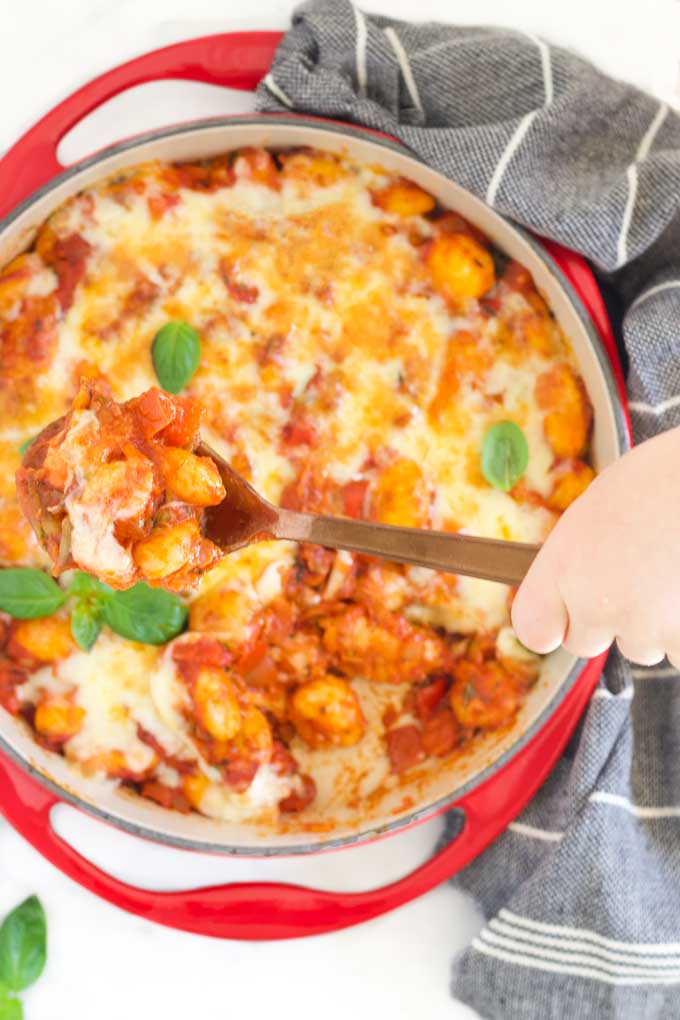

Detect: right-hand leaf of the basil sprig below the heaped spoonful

[103,581,187,645]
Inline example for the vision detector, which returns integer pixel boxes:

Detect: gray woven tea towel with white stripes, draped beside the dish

[253,0,680,1020]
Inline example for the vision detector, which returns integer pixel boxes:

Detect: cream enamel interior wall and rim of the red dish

[0,119,625,853]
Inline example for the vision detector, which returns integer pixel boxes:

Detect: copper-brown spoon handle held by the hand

[273,510,540,584]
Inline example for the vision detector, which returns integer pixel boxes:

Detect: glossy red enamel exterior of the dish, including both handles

[0,32,627,939]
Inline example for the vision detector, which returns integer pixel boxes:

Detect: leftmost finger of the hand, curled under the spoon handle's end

[512,549,569,654]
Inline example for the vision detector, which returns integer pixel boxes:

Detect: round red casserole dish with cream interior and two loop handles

[0,33,629,939]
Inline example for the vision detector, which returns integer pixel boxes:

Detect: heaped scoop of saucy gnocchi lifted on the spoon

[16,381,224,591]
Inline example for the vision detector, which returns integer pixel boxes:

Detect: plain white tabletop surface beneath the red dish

[0,0,680,1020]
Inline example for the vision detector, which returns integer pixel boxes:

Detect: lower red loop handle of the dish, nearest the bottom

[0,655,606,939]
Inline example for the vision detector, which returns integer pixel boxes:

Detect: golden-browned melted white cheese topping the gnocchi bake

[0,148,591,818]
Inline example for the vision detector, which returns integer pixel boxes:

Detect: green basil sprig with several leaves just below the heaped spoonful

[0,567,188,648]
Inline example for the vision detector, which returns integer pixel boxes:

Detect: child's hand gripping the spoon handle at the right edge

[512,428,680,668]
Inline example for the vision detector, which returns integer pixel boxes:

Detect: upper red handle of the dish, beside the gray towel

[0,32,282,219]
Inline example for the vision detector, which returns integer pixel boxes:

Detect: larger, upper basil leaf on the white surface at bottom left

[0,896,47,991]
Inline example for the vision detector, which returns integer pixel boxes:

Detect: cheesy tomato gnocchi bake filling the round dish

[0,148,593,824]
